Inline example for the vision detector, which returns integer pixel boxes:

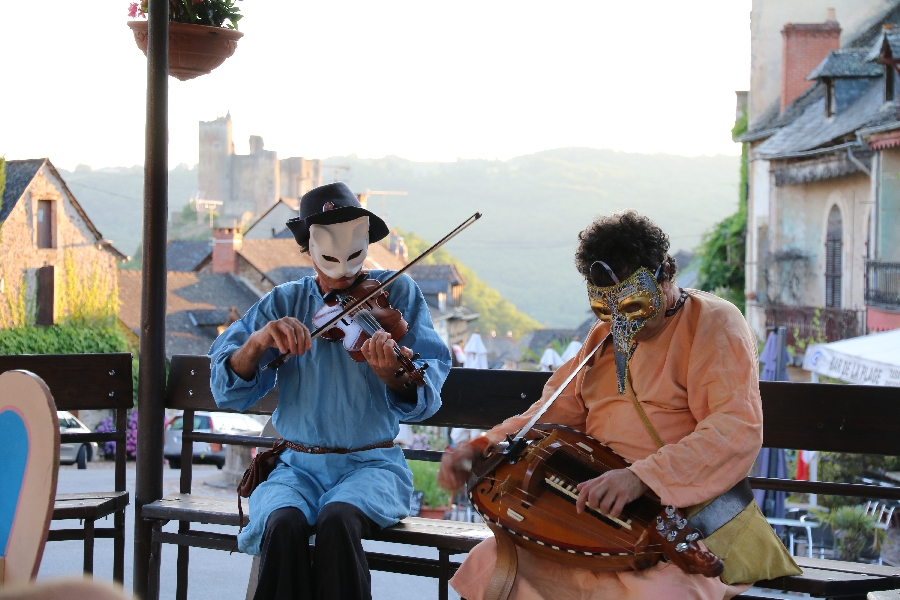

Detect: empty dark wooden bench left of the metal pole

[0,353,134,583]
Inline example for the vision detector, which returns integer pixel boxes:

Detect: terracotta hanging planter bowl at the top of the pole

[128,21,244,81]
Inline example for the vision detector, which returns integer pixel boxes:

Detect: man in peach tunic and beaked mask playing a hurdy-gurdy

[438,211,800,600]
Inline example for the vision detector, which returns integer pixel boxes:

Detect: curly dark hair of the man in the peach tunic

[575,210,678,286]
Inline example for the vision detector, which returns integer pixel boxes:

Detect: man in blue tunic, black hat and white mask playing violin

[209,183,450,600]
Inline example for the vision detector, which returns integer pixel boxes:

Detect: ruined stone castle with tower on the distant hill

[197,113,322,223]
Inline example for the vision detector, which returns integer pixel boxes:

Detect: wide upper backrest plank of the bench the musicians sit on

[166,356,900,456]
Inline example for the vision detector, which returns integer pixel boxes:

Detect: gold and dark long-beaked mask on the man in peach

[587,260,665,394]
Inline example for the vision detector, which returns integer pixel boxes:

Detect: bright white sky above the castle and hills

[0,0,750,169]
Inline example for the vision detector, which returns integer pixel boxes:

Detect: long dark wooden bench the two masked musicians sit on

[141,356,900,600]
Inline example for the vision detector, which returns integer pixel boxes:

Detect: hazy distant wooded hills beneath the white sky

[63,148,739,327]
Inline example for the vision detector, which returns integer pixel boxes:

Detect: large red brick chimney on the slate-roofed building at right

[781,8,841,112]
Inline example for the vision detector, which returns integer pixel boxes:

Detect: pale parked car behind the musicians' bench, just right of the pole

[163,411,263,469]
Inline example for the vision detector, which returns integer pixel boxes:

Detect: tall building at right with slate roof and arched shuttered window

[738,0,900,342]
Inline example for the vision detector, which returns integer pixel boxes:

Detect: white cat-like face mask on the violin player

[309,217,369,279]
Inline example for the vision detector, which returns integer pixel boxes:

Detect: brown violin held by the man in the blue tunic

[312,272,428,388]
